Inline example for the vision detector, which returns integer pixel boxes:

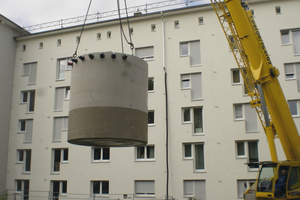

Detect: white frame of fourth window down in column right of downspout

[182,142,206,172]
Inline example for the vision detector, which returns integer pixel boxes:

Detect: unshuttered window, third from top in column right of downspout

[182,107,203,134]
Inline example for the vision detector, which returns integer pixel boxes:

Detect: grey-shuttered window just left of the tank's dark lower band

[53,117,69,142]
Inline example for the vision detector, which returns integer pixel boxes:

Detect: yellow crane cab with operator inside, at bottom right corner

[244,161,300,200]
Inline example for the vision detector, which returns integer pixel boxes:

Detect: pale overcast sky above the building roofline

[0,0,208,31]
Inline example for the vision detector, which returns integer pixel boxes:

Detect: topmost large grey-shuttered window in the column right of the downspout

[180,40,201,66]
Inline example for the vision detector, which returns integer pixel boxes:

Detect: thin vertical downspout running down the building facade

[160,11,169,200]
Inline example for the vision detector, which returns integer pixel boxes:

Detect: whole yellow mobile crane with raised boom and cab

[210,0,300,200]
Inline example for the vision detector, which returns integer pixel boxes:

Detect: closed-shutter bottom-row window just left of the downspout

[134,180,155,196]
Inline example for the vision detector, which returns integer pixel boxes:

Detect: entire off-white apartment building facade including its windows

[2,0,300,200]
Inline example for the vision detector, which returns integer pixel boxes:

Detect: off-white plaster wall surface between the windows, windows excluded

[7,0,300,200]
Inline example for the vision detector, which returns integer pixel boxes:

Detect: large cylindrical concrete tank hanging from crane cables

[68,52,148,147]
